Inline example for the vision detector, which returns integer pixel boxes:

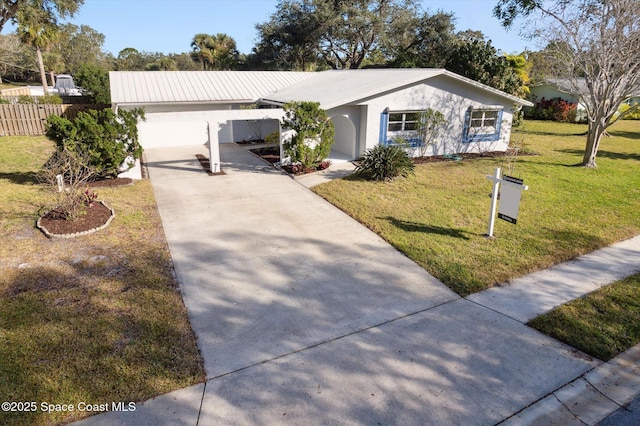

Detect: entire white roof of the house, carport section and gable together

[109,68,532,109]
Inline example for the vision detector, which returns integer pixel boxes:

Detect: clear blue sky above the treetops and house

[2,0,536,56]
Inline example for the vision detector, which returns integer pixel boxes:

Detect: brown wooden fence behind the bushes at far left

[0,104,109,136]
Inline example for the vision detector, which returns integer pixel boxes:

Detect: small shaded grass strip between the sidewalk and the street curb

[529,274,640,361]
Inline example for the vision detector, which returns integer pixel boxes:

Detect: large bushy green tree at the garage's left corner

[46,108,144,178]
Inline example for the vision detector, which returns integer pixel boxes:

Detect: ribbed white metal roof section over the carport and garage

[109,71,315,105]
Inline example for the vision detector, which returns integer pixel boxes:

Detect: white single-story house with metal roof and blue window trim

[109,69,533,175]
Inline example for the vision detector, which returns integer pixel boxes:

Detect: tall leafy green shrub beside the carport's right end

[282,102,334,169]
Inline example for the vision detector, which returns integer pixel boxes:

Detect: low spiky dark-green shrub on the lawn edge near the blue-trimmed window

[355,145,415,181]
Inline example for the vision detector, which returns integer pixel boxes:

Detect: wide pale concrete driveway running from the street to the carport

[76,145,640,425]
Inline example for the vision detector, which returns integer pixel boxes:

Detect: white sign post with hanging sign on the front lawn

[487,167,529,238]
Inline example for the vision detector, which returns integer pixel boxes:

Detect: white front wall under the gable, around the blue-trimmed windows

[359,76,513,156]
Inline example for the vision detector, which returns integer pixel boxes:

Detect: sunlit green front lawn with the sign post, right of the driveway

[314,121,640,296]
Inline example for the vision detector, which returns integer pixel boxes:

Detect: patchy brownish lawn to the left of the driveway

[0,137,205,425]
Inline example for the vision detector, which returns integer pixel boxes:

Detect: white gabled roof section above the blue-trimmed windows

[261,68,533,109]
